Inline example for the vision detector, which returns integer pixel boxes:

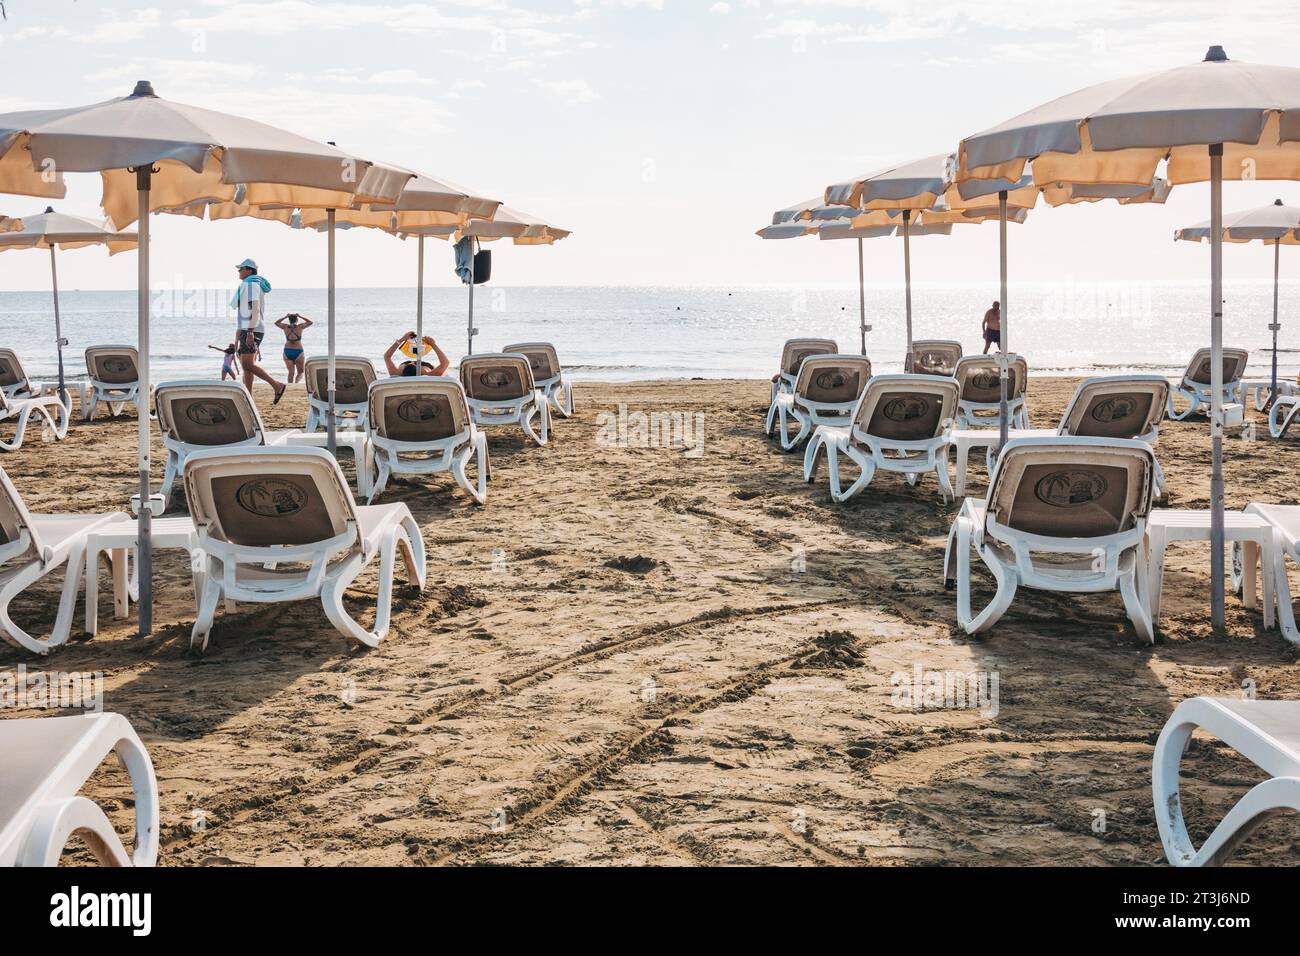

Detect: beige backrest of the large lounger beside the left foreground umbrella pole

[185,447,356,548]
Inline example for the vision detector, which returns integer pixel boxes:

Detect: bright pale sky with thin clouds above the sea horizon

[0,0,1300,290]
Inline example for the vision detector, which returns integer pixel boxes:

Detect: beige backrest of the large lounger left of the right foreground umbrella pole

[988,437,1154,537]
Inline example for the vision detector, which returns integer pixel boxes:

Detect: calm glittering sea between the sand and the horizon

[0,281,1300,381]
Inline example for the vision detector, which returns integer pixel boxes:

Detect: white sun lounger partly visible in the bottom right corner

[1151,697,1300,866]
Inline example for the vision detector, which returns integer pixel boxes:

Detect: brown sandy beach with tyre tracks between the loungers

[0,378,1300,866]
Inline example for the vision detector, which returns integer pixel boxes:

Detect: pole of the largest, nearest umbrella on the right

[1210,143,1225,633]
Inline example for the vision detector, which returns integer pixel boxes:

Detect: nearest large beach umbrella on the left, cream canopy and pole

[0,79,407,633]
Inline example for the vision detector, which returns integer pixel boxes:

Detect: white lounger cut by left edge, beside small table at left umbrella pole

[0,468,130,654]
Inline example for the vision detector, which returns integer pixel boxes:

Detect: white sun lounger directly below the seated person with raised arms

[368,376,491,505]
